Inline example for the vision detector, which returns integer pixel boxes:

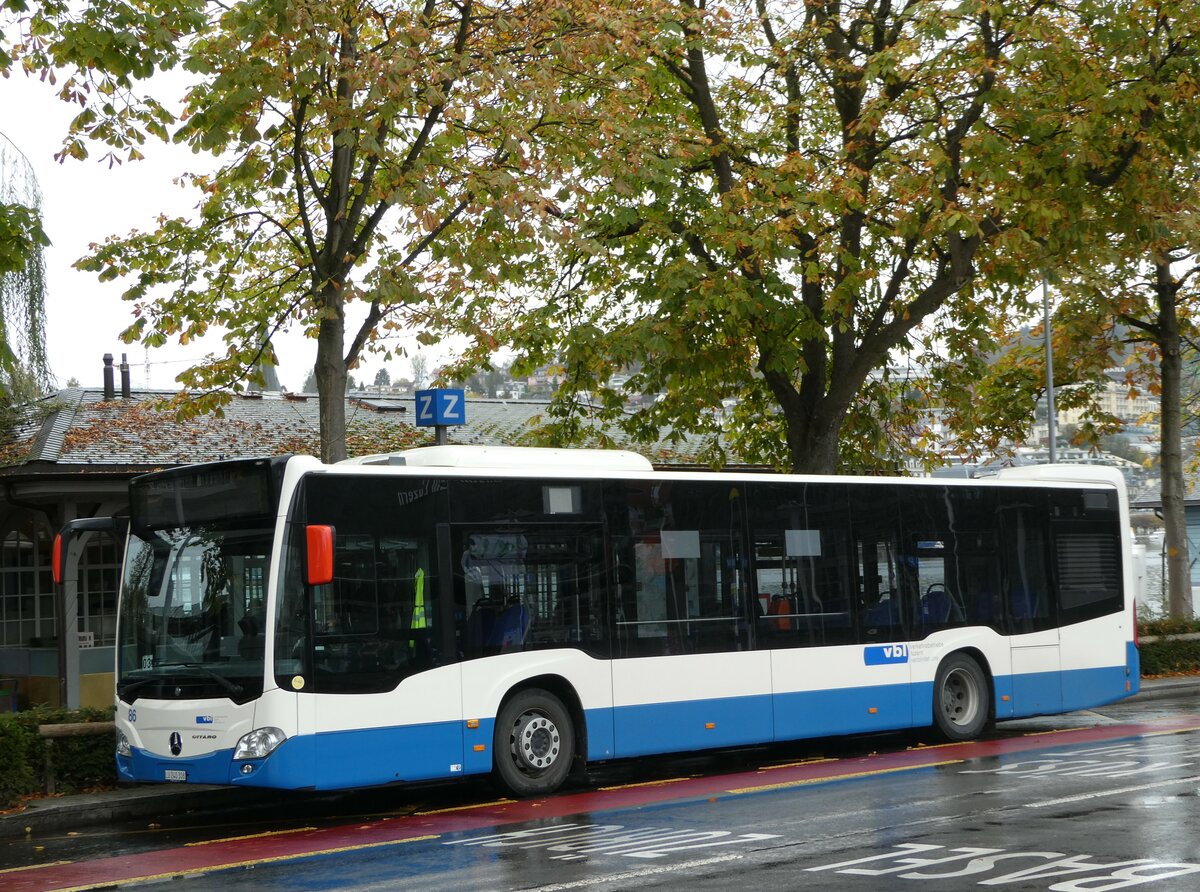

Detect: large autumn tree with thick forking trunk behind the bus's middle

[436,0,1196,471]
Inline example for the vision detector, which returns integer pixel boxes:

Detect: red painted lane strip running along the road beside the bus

[9,716,1200,892]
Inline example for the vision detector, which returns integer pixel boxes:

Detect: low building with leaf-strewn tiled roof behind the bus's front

[0,376,689,710]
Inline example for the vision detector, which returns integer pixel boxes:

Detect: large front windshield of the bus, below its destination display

[116,523,271,702]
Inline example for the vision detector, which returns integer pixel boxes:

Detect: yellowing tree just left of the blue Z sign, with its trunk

[25,0,597,460]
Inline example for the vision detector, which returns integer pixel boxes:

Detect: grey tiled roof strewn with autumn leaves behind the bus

[0,388,700,475]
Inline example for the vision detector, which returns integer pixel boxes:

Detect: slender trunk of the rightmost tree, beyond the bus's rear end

[1156,264,1193,618]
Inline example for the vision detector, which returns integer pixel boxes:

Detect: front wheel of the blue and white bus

[493,688,575,796]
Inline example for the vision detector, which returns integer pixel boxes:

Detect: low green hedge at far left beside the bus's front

[0,706,116,808]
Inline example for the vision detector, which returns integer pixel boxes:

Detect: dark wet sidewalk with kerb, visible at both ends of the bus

[0,676,1200,839]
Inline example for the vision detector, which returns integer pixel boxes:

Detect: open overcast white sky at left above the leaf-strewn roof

[0,71,439,390]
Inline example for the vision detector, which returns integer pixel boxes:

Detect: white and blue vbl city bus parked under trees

[66,447,1139,796]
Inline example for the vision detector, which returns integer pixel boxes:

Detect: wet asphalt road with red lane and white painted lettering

[0,694,1200,892]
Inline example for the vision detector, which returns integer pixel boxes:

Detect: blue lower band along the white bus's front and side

[118,662,1139,790]
